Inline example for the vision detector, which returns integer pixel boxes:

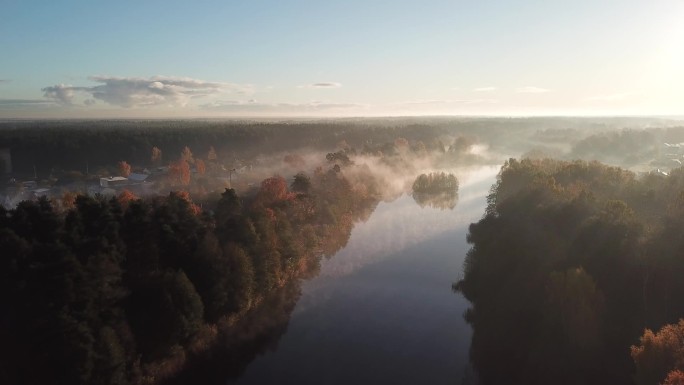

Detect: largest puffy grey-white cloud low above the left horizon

[42,76,253,108]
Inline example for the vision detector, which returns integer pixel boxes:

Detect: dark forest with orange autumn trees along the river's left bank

[0,160,377,384]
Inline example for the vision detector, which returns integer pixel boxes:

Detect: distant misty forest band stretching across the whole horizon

[0,118,684,178]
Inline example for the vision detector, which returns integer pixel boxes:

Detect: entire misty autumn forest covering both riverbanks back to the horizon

[6,118,684,385]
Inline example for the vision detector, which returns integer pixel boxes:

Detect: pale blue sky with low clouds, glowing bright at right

[0,0,684,119]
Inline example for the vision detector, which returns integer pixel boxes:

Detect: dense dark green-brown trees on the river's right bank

[454,159,684,384]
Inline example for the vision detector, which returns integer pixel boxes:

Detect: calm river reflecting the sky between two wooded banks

[230,167,498,384]
